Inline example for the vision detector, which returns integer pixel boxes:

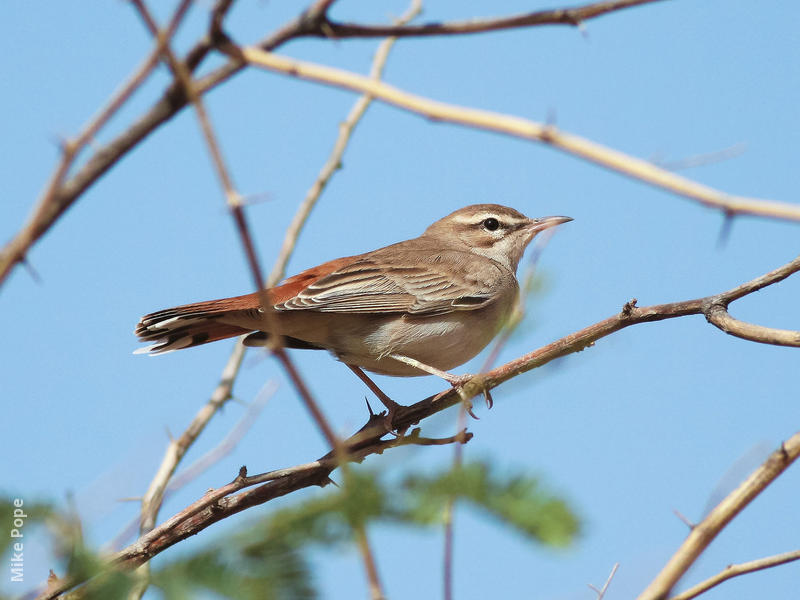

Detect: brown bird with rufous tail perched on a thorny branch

[134,204,572,413]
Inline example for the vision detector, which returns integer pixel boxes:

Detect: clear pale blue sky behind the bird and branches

[0,0,800,600]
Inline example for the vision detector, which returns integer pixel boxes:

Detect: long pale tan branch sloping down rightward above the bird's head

[230,45,800,221]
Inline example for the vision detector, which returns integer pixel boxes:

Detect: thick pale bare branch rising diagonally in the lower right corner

[638,432,800,600]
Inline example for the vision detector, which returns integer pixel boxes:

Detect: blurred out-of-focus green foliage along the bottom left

[0,462,578,600]
